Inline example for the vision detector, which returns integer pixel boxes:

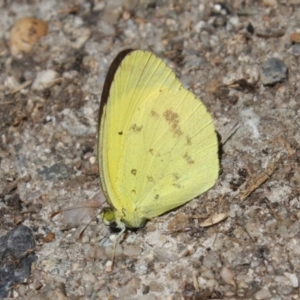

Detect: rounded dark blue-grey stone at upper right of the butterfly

[261,57,288,85]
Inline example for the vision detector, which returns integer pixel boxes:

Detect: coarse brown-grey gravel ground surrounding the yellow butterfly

[0,0,300,300]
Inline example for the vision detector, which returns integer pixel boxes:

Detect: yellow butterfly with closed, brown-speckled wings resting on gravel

[98,50,219,232]
